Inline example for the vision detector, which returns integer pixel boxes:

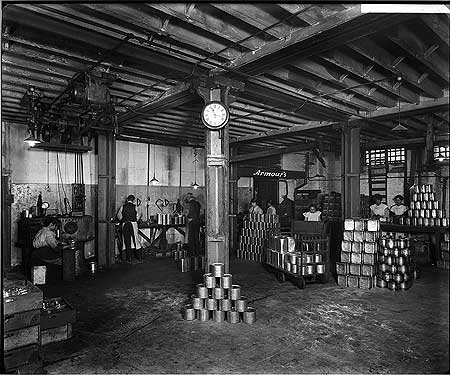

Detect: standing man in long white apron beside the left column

[116,194,143,262]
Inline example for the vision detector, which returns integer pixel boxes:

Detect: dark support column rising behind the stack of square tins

[342,123,361,218]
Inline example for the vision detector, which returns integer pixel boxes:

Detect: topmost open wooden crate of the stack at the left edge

[3,280,43,316]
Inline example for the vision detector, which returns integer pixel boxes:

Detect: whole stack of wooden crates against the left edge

[3,280,43,373]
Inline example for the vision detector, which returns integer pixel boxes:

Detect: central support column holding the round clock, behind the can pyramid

[205,88,230,272]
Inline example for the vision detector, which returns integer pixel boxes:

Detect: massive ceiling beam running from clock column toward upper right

[218,5,410,75]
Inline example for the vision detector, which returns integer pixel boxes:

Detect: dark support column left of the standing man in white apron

[96,133,116,267]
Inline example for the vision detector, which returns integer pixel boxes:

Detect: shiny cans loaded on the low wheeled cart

[265,234,326,276]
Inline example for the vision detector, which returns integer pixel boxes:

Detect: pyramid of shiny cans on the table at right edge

[400,184,450,227]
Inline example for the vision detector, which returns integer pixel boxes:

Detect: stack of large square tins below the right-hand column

[336,219,380,289]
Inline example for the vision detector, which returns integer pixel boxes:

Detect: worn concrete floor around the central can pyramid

[43,259,449,373]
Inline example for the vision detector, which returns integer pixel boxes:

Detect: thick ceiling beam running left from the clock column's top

[118,83,198,126]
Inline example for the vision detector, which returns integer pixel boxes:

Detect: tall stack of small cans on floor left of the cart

[237,214,280,262]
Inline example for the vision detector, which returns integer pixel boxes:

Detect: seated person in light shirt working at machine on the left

[30,217,66,280]
